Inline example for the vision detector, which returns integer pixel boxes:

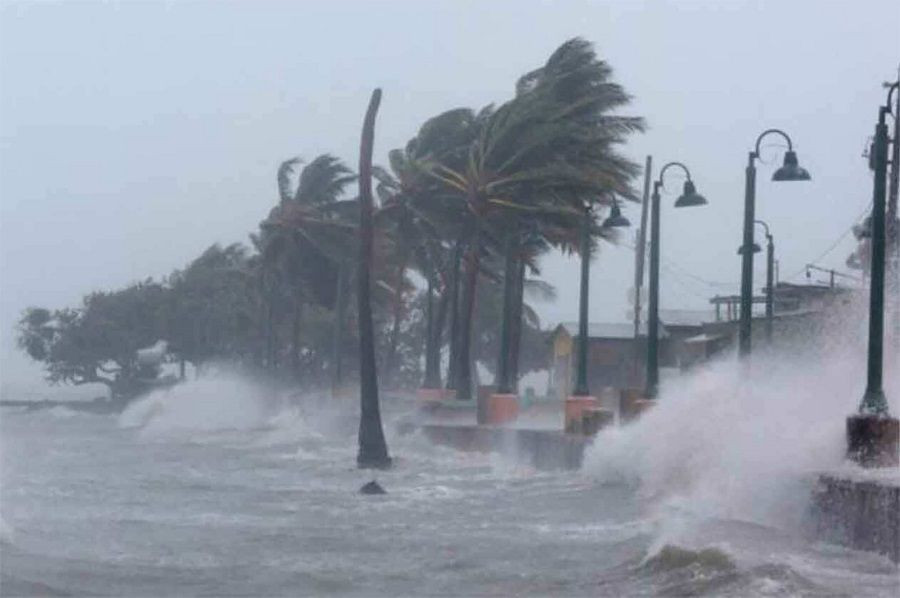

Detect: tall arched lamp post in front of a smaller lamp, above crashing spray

[738,129,810,356]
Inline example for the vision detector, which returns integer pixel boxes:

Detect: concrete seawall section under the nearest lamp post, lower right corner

[812,474,900,563]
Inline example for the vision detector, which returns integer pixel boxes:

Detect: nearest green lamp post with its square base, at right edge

[847,83,900,466]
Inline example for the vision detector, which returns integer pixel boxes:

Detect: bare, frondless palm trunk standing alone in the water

[356,89,391,469]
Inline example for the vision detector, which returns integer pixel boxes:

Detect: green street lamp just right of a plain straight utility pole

[646,162,706,399]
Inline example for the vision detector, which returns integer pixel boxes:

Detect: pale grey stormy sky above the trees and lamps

[0,0,900,398]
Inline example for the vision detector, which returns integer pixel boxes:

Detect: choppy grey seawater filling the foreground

[0,368,900,596]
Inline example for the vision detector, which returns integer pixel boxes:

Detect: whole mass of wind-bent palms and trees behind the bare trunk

[18,38,643,404]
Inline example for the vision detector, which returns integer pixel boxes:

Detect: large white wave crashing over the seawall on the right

[584,338,900,540]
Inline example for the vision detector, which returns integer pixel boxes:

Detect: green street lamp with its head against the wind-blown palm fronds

[564,198,631,432]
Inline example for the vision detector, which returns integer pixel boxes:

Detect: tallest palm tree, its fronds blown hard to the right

[431,38,642,398]
